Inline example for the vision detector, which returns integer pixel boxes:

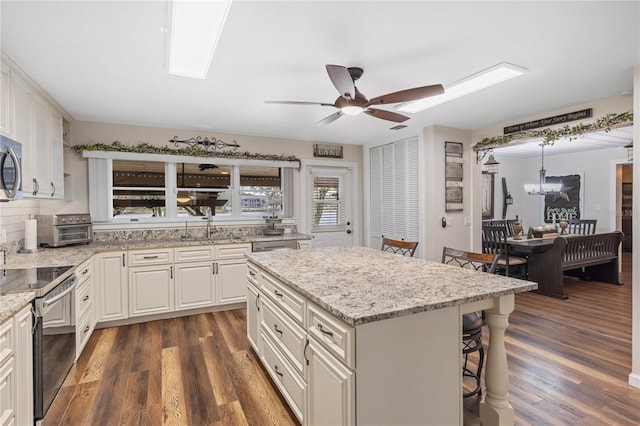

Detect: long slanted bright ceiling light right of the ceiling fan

[396,62,527,112]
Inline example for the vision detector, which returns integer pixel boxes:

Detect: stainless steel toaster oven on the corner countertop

[36,213,93,247]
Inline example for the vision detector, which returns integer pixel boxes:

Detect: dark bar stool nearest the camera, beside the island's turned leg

[442,247,500,398]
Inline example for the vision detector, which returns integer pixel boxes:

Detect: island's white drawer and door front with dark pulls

[246,263,356,425]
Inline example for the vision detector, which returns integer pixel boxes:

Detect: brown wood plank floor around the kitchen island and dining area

[45,253,640,425]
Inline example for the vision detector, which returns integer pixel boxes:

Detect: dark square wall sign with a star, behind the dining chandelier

[544,173,583,223]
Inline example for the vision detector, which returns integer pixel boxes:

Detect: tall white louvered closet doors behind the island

[369,137,423,256]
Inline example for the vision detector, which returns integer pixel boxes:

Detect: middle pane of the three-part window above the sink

[176,163,231,217]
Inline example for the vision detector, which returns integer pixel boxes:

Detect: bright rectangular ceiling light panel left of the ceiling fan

[169,0,231,79]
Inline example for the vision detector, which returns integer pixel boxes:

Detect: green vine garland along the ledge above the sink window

[71,141,300,163]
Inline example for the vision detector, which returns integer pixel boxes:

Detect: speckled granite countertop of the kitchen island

[246,246,538,326]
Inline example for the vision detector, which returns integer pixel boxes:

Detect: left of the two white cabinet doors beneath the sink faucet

[175,262,215,310]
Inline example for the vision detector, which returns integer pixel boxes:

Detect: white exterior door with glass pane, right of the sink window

[307,167,354,247]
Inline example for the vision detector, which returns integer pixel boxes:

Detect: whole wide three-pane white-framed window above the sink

[89,153,298,223]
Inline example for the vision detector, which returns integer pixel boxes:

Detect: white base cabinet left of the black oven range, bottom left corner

[0,305,33,426]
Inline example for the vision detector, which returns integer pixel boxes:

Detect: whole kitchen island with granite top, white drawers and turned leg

[246,247,537,425]
